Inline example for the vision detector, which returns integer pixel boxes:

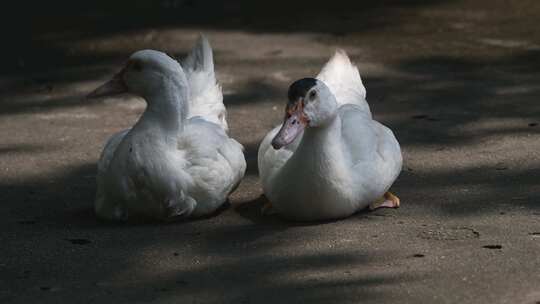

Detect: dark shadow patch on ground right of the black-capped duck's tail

[366,52,540,146]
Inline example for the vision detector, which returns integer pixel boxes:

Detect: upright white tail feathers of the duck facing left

[180,35,228,131]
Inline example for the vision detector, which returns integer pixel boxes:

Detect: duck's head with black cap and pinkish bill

[272,78,338,149]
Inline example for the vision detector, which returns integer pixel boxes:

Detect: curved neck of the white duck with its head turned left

[135,78,189,145]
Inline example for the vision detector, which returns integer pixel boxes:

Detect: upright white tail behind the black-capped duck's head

[317,49,371,115]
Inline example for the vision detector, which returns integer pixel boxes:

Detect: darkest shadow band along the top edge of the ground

[4,0,456,82]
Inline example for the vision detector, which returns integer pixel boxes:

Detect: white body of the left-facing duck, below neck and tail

[95,117,246,220]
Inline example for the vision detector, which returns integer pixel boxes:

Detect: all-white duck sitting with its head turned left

[89,37,246,220]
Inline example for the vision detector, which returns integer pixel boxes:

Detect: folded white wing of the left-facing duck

[178,117,246,212]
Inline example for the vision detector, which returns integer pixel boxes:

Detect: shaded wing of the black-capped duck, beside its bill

[257,125,303,185]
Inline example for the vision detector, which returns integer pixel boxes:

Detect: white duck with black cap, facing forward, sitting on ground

[258,50,402,221]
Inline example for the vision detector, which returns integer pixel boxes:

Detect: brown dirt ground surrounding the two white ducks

[0,0,540,304]
